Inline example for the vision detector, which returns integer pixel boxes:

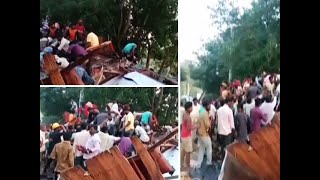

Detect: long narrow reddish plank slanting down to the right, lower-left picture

[131,137,164,180]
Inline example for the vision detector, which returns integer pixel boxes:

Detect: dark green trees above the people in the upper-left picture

[40,0,178,75]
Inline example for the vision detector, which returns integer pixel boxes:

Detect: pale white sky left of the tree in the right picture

[178,0,252,62]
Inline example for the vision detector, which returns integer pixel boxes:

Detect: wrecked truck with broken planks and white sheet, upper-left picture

[40,41,178,85]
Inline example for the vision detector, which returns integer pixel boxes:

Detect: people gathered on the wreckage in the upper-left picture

[40,17,137,85]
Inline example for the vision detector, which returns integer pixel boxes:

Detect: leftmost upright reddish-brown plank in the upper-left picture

[43,54,65,85]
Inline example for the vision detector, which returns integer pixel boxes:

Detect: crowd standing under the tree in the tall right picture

[180,72,280,176]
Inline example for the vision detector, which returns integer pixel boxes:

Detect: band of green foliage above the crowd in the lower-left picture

[40,87,178,124]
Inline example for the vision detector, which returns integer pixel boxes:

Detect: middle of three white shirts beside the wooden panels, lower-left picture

[83,133,101,159]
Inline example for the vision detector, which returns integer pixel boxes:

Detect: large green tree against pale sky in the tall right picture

[191,0,280,93]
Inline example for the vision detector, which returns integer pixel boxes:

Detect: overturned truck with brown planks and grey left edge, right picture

[219,113,280,180]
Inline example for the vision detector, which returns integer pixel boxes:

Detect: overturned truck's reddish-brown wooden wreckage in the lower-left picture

[61,129,178,180]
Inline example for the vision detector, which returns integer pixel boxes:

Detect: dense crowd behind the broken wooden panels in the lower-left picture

[40,100,165,179]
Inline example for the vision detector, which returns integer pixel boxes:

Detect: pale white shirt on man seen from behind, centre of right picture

[217,104,234,135]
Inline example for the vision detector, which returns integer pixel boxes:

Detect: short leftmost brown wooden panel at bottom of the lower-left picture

[60,166,93,180]
